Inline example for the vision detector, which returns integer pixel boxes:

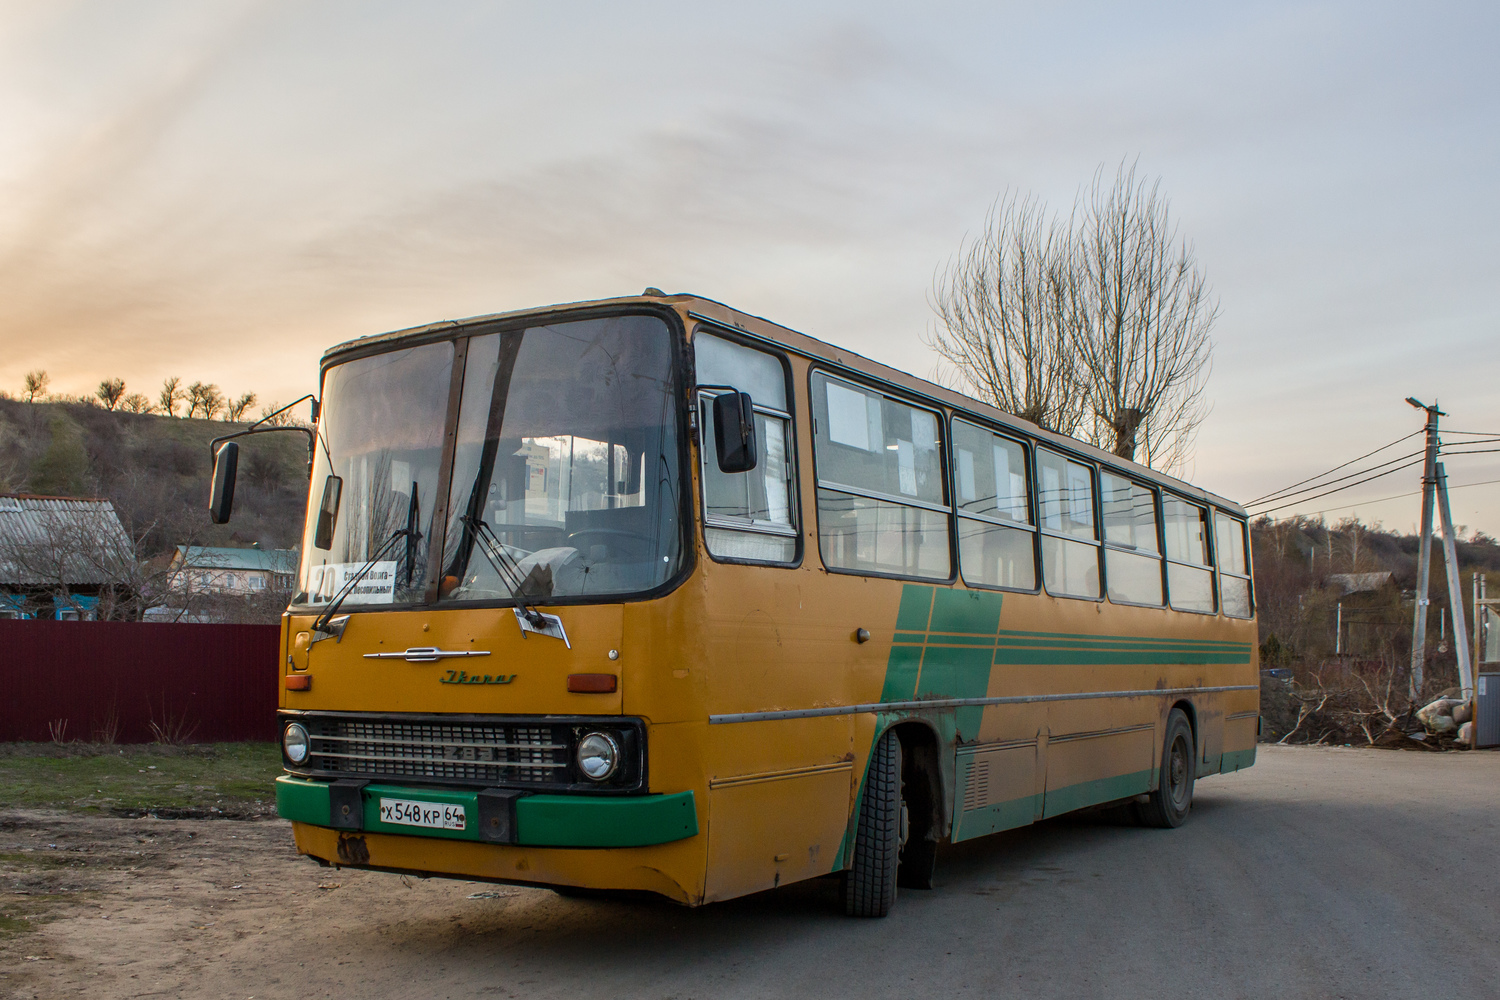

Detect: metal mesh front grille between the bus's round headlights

[306,717,570,784]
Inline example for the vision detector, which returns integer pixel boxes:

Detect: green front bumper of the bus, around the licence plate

[276,775,698,847]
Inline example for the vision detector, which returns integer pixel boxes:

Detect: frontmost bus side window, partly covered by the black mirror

[693,333,798,562]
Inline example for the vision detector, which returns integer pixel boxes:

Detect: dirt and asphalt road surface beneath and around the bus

[0,748,1500,1000]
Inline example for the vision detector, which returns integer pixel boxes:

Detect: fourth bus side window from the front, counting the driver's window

[1037,448,1100,600]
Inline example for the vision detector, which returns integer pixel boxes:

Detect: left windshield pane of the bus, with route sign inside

[293,342,453,607]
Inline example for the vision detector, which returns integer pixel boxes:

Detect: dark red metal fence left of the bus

[0,621,281,744]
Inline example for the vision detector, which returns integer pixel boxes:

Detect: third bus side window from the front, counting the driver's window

[953,420,1037,591]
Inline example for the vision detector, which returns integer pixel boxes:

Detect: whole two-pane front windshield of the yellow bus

[294,315,683,607]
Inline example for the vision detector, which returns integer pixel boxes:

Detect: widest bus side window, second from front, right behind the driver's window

[812,373,953,580]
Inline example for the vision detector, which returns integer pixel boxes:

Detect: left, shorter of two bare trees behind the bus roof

[927,193,1085,435]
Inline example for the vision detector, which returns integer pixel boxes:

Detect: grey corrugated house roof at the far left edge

[0,493,135,586]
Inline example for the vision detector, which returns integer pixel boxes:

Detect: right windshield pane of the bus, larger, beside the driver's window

[438,315,683,603]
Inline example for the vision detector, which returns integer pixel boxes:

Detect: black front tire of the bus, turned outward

[845,733,902,916]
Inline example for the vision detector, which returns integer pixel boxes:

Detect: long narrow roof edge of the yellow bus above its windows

[323,289,1245,516]
